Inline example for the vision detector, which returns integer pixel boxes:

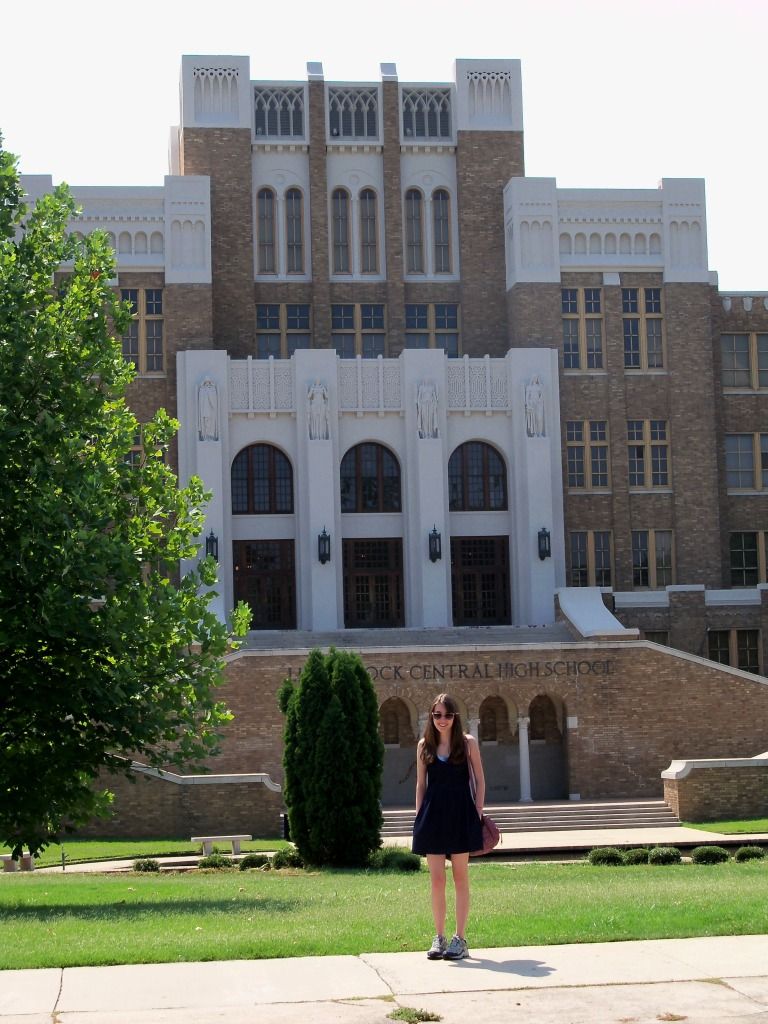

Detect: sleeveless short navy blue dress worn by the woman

[412,758,482,856]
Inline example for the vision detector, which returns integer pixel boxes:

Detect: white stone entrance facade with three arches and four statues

[177,349,565,631]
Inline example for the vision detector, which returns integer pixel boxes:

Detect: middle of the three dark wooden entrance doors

[343,538,404,629]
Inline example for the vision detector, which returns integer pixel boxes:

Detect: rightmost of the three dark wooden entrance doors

[451,537,511,626]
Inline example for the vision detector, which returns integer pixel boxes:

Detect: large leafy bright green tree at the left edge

[0,139,248,854]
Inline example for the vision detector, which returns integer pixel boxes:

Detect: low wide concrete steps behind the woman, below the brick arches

[381,800,680,837]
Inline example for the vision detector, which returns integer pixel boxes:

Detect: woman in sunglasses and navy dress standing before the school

[413,693,485,961]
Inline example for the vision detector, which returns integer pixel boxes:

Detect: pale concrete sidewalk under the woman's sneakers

[0,935,768,1024]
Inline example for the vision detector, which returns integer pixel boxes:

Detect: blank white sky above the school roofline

[0,0,768,292]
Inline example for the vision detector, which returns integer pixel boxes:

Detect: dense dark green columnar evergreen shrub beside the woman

[279,647,384,867]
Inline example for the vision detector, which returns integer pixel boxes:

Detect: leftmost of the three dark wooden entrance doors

[232,541,296,630]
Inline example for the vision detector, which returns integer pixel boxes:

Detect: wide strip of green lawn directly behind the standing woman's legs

[0,860,768,968]
